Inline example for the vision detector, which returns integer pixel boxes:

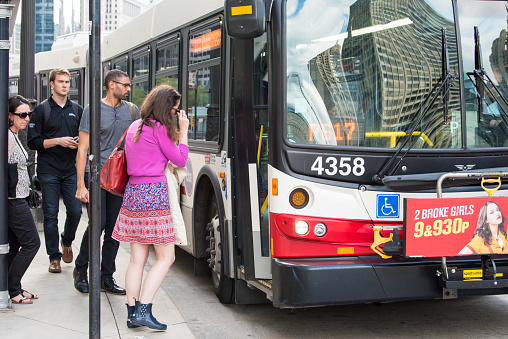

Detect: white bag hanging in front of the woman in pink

[164,163,187,246]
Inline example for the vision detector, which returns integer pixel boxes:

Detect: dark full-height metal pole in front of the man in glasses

[88,0,101,339]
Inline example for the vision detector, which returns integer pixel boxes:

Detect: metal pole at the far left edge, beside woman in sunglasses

[0,1,13,309]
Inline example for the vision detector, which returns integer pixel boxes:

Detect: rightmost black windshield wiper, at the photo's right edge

[466,26,508,121]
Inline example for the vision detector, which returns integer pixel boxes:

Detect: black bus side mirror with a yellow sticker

[224,0,265,39]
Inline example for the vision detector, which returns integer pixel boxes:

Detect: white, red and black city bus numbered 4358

[26,0,508,308]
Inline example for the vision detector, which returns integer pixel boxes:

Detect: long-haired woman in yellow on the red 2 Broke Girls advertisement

[459,201,508,254]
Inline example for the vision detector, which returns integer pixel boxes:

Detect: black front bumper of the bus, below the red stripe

[272,256,508,307]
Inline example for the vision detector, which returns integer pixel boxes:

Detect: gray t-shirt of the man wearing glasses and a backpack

[79,101,140,172]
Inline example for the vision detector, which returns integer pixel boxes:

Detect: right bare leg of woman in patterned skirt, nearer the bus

[138,244,175,304]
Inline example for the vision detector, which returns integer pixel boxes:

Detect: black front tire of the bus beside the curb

[206,198,234,304]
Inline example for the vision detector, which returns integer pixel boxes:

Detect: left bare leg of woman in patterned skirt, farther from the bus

[125,243,150,306]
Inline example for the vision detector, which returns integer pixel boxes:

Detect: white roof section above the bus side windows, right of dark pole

[101,0,224,60]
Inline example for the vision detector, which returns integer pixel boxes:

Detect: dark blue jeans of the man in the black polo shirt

[37,173,82,261]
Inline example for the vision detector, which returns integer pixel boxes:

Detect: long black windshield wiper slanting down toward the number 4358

[372,27,458,183]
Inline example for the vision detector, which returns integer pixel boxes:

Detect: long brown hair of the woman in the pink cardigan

[132,85,181,143]
